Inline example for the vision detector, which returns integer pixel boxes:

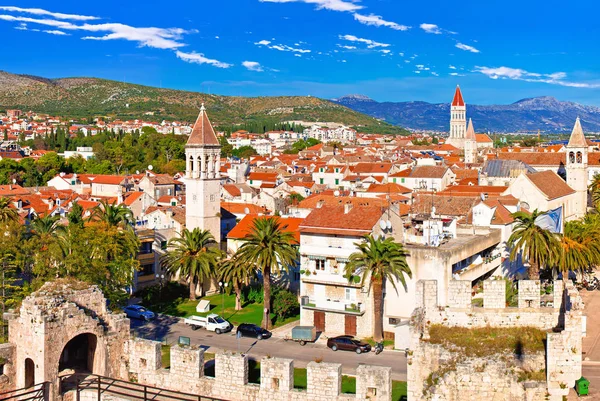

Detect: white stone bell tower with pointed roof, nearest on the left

[185,104,221,242]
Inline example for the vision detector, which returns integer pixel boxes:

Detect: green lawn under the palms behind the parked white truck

[165,294,300,327]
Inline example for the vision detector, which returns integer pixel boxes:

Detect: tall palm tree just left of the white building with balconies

[238,217,298,330]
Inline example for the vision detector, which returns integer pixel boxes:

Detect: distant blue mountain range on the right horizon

[333,95,600,133]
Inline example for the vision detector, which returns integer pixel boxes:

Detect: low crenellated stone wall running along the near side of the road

[129,339,392,401]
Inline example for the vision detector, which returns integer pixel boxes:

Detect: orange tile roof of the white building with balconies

[300,205,383,236]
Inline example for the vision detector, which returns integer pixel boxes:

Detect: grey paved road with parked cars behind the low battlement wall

[131,315,406,380]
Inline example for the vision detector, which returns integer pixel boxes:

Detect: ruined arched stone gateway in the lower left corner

[3,280,129,399]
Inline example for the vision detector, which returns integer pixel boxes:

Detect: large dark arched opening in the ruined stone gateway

[58,333,98,373]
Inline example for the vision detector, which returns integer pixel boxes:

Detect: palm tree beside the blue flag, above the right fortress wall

[508,209,559,279]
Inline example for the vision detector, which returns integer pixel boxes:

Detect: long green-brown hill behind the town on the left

[0,71,405,133]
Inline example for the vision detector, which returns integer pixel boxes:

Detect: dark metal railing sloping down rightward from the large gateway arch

[60,374,226,401]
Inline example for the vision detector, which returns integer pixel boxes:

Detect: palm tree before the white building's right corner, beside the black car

[344,235,412,341]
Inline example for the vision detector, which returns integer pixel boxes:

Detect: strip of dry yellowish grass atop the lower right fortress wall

[427,324,546,357]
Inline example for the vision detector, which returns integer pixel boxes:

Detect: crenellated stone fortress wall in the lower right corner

[408,280,583,401]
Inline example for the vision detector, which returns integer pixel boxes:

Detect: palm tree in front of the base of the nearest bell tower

[163,228,222,300]
